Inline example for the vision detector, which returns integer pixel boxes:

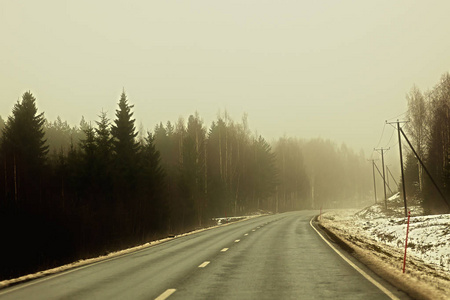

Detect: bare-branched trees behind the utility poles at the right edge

[404,73,450,213]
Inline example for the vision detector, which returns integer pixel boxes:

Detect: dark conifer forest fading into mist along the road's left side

[0,92,370,279]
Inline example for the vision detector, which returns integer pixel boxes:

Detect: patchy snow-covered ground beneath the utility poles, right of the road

[321,194,450,295]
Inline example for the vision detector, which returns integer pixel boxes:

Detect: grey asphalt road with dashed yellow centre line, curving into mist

[0,211,407,300]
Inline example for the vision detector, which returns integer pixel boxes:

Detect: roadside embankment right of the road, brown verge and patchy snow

[318,205,450,299]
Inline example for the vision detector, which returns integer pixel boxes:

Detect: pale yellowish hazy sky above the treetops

[0,0,450,155]
